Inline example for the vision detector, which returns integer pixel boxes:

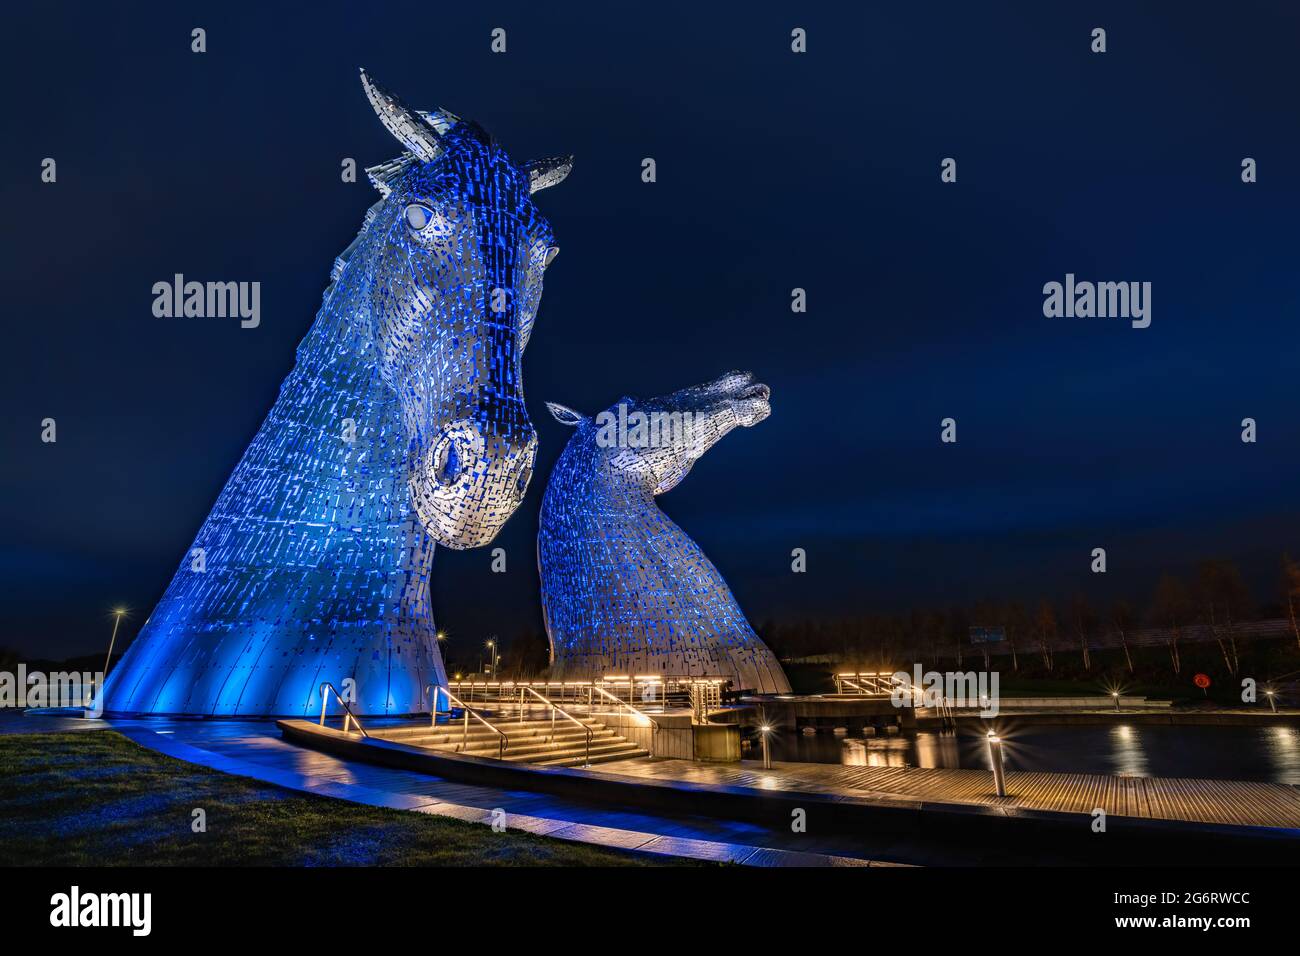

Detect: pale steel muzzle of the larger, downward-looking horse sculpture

[411,419,537,550]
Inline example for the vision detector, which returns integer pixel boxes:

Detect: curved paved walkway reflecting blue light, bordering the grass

[0,711,900,866]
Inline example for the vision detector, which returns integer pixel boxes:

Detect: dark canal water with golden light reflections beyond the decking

[745,723,1300,784]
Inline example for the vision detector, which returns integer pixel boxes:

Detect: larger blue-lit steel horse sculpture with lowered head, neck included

[107,70,571,715]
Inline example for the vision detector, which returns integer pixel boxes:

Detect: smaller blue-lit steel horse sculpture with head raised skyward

[537,372,790,693]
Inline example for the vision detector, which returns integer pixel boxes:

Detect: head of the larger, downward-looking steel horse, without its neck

[361,70,572,549]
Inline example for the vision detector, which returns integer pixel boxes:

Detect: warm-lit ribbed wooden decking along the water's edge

[601,760,1300,829]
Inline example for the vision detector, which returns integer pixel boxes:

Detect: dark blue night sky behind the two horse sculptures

[0,1,1300,657]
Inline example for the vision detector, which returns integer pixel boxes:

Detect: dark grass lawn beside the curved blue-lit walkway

[0,731,690,866]
